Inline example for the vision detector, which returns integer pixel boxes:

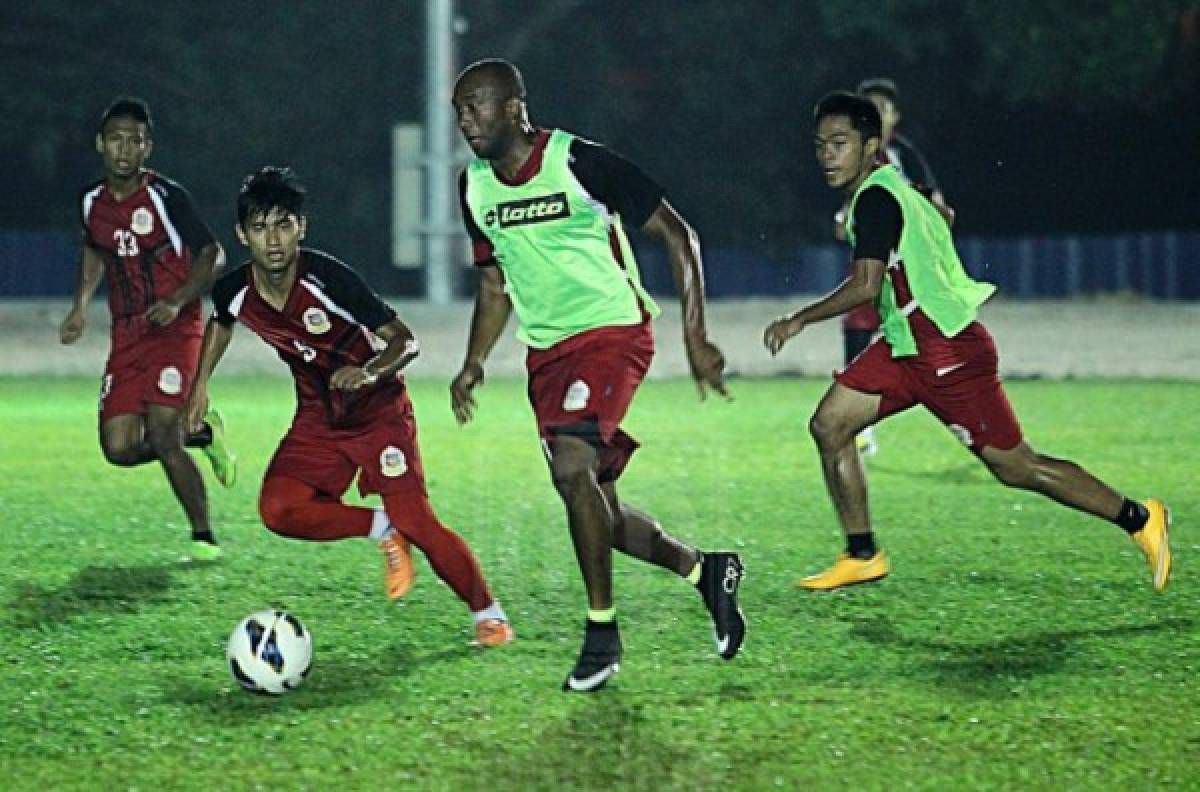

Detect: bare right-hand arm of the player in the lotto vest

[642,198,730,398]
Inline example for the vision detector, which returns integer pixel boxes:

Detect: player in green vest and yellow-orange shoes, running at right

[763,92,1171,590]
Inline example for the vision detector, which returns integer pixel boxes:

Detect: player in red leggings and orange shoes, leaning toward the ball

[187,167,512,647]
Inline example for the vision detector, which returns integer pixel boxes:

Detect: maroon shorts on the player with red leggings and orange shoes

[264,394,425,498]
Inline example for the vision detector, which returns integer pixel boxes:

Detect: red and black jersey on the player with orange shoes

[212,248,404,428]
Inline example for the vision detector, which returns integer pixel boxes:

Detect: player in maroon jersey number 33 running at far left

[59,97,238,560]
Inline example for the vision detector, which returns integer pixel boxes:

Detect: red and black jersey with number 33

[79,170,214,340]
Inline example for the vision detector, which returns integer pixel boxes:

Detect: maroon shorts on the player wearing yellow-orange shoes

[834,322,1021,454]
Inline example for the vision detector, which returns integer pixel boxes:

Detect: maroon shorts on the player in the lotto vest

[526,320,654,481]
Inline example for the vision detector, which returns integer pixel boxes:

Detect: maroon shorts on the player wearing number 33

[100,335,202,424]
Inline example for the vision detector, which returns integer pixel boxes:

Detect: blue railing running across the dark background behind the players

[0,232,1200,300]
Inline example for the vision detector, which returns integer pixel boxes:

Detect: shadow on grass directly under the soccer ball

[164,644,476,725]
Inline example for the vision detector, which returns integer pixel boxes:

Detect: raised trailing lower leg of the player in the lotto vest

[600,481,746,660]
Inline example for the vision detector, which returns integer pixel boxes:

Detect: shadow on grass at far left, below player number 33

[6,564,180,630]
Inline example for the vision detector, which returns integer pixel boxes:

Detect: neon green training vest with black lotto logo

[467,130,660,349]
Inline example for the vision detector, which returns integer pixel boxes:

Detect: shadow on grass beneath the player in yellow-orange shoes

[850,617,1196,697]
